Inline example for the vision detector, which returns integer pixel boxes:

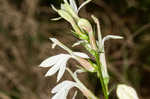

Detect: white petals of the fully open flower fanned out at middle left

[40,52,89,82]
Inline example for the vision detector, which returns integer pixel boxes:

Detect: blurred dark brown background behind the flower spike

[0,0,150,99]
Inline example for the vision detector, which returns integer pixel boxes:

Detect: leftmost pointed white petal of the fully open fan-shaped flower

[40,54,61,67]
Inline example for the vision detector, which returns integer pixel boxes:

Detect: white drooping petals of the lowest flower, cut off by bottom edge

[51,80,78,99]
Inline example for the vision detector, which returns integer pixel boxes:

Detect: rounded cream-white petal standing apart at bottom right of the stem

[117,84,139,99]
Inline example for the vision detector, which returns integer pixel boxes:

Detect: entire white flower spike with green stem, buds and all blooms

[40,0,138,99]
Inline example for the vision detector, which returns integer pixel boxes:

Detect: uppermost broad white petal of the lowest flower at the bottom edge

[51,80,77,93]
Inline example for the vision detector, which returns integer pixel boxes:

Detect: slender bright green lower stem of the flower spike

[96,54,109,99]
